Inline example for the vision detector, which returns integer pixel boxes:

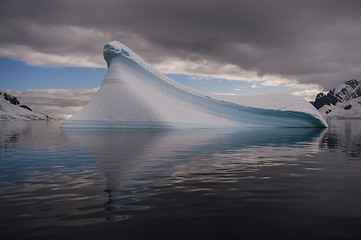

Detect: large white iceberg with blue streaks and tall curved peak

[62,41,327,128]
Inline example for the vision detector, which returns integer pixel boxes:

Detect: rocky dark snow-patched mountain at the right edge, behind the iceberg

[312,79,361,119]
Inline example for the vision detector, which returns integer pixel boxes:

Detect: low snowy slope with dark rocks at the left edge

[0,90,51,120]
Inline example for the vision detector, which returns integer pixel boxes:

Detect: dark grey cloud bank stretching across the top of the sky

[0,0,361,89]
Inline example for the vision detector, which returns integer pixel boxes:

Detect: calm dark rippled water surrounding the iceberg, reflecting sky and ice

[0,120,361,239]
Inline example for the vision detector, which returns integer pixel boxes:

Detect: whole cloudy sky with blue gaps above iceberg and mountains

[0,0,361,117]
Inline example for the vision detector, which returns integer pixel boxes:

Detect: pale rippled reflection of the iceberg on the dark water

[62,128,324,221]
